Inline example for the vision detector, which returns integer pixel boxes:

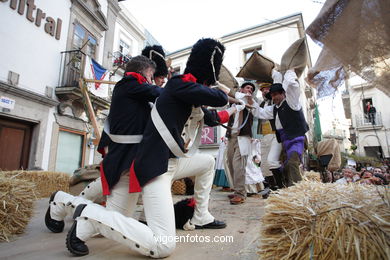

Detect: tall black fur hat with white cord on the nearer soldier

[184,38,225,85]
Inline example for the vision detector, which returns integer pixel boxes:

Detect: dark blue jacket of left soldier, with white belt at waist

[99,72,162,195]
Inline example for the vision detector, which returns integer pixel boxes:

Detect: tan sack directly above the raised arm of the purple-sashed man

[280,38,308,78]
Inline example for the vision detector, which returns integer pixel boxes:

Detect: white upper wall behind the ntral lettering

[0,0,71,94]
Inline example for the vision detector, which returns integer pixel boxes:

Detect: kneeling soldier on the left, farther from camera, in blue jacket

[45,56,162,233]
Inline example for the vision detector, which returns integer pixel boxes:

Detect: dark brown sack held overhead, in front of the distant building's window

[236,51,275,83]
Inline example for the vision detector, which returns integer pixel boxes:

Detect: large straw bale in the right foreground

[258,181,390,259]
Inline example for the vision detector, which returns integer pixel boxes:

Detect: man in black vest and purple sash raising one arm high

[253,70,309,187]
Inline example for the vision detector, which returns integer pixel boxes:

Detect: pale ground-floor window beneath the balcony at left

[55,128,85,174]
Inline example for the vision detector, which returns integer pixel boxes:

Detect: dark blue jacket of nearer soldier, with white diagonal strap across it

[130,74,228,192]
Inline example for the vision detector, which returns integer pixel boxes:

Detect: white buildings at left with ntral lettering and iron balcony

[0,0,157,174]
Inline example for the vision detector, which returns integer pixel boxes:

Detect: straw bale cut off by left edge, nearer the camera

[0,176,36,242]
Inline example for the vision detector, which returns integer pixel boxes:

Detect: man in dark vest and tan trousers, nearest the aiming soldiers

[226,82,255,205]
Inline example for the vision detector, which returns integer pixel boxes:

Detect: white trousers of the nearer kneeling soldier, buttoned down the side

[76,154,214,258]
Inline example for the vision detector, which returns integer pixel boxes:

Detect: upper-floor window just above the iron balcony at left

[72,24,97,58]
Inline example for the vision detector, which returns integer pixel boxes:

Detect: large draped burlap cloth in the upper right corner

[306,0,390,96]
